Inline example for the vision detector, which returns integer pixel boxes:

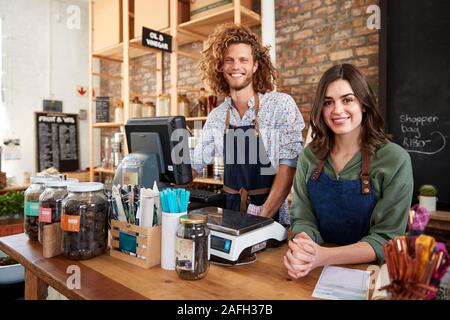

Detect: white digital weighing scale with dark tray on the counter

[190,207,287,264]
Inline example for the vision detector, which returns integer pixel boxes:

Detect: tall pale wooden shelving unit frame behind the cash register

[89,0,261,184]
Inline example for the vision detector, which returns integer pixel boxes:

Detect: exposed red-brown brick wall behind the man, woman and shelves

[101,0,378,134]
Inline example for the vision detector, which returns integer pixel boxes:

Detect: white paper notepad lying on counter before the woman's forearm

[312,266,370,300]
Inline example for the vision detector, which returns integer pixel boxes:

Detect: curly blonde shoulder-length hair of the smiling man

[200,23,278,96]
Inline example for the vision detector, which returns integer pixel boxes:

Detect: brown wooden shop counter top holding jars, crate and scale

[0,234,367,300]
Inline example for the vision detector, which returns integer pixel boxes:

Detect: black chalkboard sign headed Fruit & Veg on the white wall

[35,112,80,172]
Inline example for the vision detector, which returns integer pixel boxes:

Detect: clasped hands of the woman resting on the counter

[283,232,325,279]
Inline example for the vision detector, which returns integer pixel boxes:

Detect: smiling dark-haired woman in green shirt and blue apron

[284,64,413,278]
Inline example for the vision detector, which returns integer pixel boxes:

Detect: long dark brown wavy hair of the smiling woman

[310,64,390,160]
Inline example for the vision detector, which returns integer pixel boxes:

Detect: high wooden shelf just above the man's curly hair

[178,5,261,46]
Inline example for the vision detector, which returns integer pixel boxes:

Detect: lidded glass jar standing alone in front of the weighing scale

[175,214,210,280]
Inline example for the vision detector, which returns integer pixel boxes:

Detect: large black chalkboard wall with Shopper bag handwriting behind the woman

[382,0,450,210]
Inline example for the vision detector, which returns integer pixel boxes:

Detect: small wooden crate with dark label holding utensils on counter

[109,220,161,269]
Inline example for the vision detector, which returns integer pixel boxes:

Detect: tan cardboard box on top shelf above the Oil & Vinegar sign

[134,0,190,38]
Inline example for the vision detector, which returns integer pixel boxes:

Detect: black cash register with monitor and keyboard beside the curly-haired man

[113,116,225,210]
